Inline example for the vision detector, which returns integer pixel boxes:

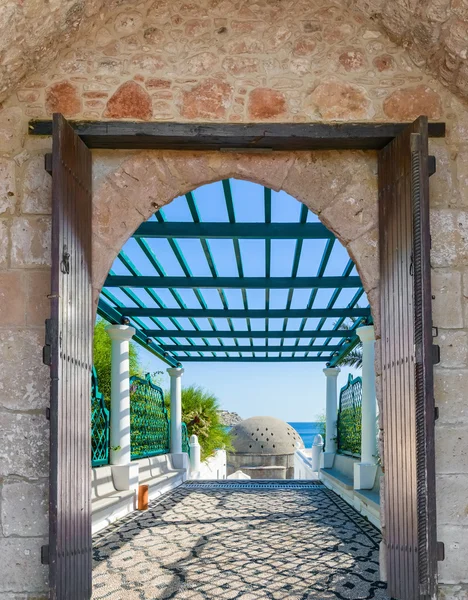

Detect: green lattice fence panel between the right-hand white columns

[337,375,362,456]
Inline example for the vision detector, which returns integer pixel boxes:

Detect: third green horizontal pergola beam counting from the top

[118,306,370,319]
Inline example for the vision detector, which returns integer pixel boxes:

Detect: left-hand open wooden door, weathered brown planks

[45,114,93,600]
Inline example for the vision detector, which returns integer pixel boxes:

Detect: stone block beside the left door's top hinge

[21,155,52,215]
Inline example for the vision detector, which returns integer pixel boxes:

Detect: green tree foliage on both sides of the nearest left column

[93,319,143,408]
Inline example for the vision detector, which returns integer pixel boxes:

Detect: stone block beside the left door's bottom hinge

[0,537,48,598]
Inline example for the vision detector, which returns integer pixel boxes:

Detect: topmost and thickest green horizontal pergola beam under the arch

[133,221,335,240]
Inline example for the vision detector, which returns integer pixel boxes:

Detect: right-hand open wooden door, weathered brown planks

[379,117,437,600]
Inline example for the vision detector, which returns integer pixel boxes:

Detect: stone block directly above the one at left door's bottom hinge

[1,479,49,537]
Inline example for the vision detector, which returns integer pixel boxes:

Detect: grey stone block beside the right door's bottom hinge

[437,525,468,584]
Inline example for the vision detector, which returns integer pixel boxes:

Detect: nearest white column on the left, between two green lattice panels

[106,325,135,465]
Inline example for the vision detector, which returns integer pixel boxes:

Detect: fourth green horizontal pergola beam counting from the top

[143,329,356,338]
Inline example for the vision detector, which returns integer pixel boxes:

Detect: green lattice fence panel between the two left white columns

[130,374,170,460]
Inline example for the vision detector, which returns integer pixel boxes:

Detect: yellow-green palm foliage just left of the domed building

[166,385,231,460]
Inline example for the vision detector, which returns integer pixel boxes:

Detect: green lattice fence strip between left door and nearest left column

[91,367,110,467]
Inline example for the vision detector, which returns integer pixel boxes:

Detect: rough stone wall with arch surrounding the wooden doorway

[0,0,468,600]
